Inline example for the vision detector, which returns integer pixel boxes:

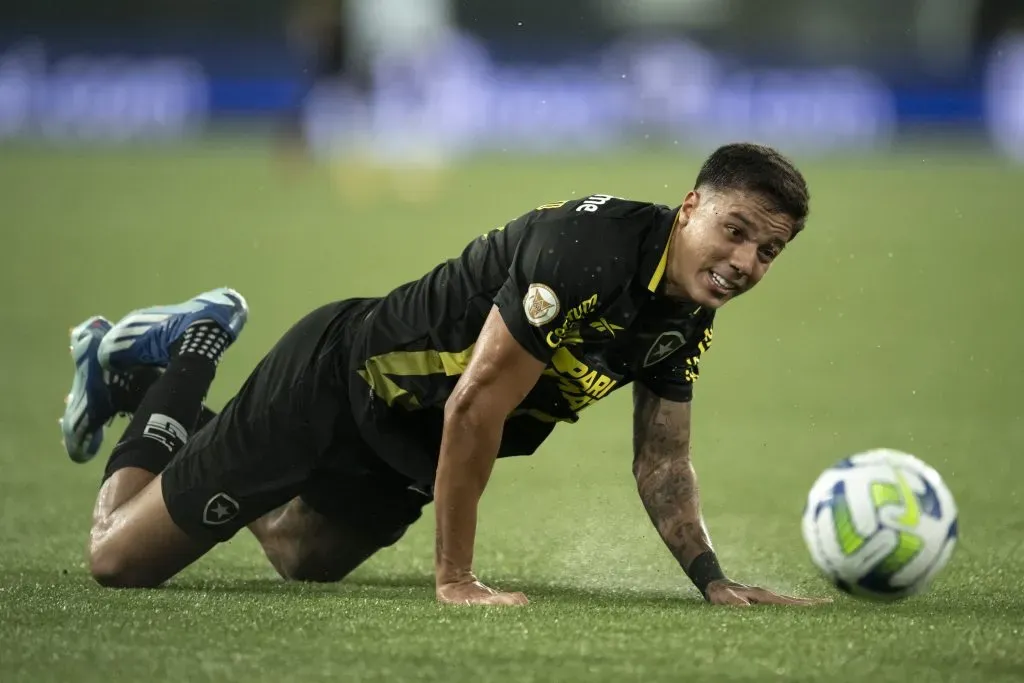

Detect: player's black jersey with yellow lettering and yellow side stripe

[351,195,714,481]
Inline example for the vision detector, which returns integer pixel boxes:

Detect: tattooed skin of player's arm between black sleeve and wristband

[633,383,712,570]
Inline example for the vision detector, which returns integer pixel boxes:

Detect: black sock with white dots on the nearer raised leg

[103,321,230,480]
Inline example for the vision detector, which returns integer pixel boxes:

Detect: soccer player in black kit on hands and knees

[62,144,816,605]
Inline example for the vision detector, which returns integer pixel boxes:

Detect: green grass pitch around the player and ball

[0,145,1024,683]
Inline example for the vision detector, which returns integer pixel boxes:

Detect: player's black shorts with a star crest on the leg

[162,299,431,547]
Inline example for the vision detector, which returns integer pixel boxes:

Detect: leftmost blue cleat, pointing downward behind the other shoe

[60,315,116,463]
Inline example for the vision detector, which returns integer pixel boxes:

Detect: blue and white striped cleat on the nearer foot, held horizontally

[98,287,249,371]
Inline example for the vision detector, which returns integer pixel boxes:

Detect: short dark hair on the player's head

[693,142,811,239]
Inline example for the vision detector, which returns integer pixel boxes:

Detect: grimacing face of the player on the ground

[667,190,794,308]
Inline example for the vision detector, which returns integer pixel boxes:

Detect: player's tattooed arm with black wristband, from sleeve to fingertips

[633,382,831,605]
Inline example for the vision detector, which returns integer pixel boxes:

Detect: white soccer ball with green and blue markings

[803,449,956,600]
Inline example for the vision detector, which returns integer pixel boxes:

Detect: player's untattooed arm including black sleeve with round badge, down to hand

[434,196,628,604]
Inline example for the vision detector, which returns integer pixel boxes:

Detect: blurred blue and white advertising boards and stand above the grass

[0,0,1024,161]
